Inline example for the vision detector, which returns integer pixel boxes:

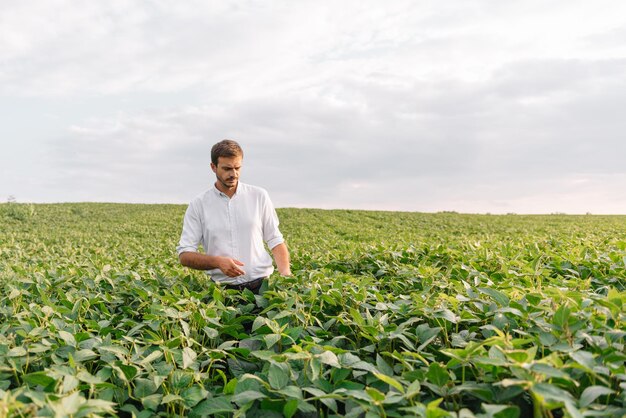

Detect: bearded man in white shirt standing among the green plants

[176,139,291,293]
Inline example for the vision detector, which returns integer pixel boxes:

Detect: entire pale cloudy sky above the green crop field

[0,0,626,214]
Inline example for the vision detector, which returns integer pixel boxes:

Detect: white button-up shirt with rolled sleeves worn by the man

[176,182,284,284]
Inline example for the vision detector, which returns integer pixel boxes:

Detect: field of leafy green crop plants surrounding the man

[0,203,626,418]
